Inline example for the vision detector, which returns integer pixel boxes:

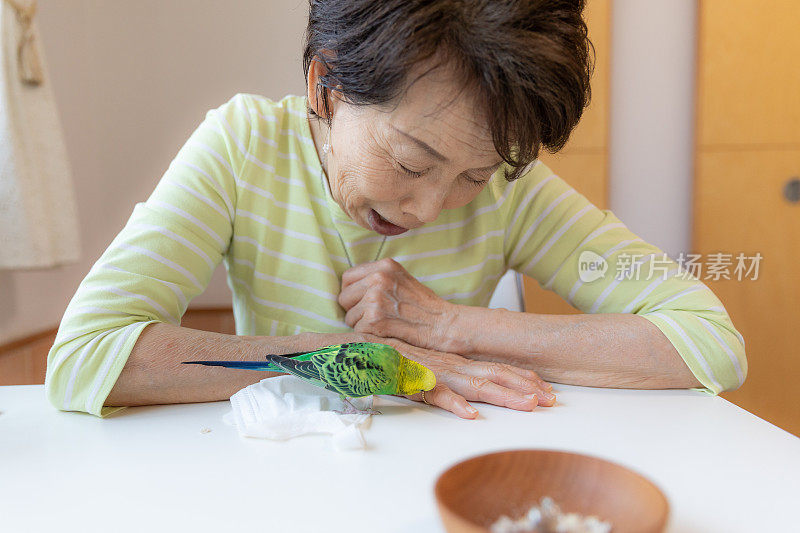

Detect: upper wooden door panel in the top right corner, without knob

[697,0,800,148]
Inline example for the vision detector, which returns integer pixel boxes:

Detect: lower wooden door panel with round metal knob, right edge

[694,150,800,435]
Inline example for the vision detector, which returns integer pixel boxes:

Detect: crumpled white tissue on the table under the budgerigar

[223,375,374,450]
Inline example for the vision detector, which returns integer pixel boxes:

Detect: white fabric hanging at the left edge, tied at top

[0,0,80,269]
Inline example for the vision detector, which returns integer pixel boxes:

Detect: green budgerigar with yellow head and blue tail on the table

[184,342,436,412]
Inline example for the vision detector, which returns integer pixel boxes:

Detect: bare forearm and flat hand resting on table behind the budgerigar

[106,323,555,418]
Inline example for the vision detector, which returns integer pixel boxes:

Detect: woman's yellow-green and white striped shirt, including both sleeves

[46,94,747,416]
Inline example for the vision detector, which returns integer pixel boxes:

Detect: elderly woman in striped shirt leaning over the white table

[46,0,746,418]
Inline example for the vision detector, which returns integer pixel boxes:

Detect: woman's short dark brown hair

[303,0,594,181]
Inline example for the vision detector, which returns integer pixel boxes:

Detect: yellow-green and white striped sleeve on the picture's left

[45,94,252,416]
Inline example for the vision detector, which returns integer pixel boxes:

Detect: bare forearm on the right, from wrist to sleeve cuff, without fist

[441,306,702,389]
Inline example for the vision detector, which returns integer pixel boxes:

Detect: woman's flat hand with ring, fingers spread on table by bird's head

[361,335,556,418]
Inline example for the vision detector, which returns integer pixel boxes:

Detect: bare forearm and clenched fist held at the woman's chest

[339,259,713,389]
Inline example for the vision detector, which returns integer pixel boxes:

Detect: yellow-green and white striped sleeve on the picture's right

[505,163,747,394]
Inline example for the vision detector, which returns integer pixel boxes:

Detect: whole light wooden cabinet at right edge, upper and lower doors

[693,0,800,435]
